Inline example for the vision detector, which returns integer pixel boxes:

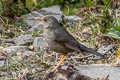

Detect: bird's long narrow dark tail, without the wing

[79,44,105,58]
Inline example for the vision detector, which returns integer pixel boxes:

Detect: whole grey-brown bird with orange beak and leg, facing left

[34,15,104,71]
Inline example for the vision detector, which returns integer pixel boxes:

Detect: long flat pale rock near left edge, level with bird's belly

[3,46,28,54]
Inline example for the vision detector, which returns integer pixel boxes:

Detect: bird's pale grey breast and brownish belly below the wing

[44,29,73,53]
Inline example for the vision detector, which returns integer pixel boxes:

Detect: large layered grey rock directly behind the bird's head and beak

[23,6,62,32]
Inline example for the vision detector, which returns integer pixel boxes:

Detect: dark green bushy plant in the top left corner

[0,0,27,18]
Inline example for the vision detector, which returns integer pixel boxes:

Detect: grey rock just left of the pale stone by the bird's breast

[13,34,34,46]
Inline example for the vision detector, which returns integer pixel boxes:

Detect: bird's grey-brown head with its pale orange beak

[34,16,59,29]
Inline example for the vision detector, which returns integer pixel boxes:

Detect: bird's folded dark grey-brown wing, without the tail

[55,27,80,51]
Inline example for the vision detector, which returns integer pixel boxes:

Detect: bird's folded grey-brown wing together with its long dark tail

[55,27,104,58]
